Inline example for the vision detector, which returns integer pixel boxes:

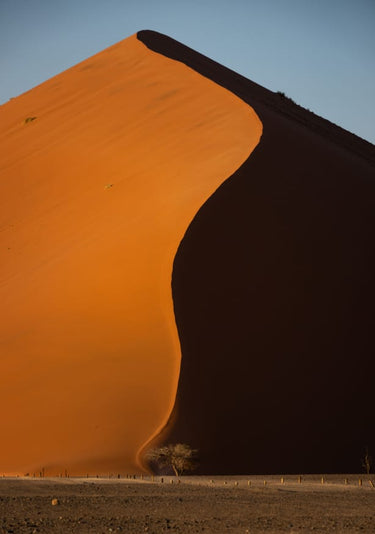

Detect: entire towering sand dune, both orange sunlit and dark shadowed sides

[0,31,375,480]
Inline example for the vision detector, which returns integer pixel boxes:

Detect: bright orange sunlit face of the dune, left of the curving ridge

[0,36,262,474]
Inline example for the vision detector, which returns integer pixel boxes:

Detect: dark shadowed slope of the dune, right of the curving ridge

[139,32,375,474]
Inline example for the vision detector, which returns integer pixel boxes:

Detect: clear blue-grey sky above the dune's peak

[0,0,375,144]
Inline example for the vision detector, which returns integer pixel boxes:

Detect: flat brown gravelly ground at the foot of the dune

[0,475,375,533]
